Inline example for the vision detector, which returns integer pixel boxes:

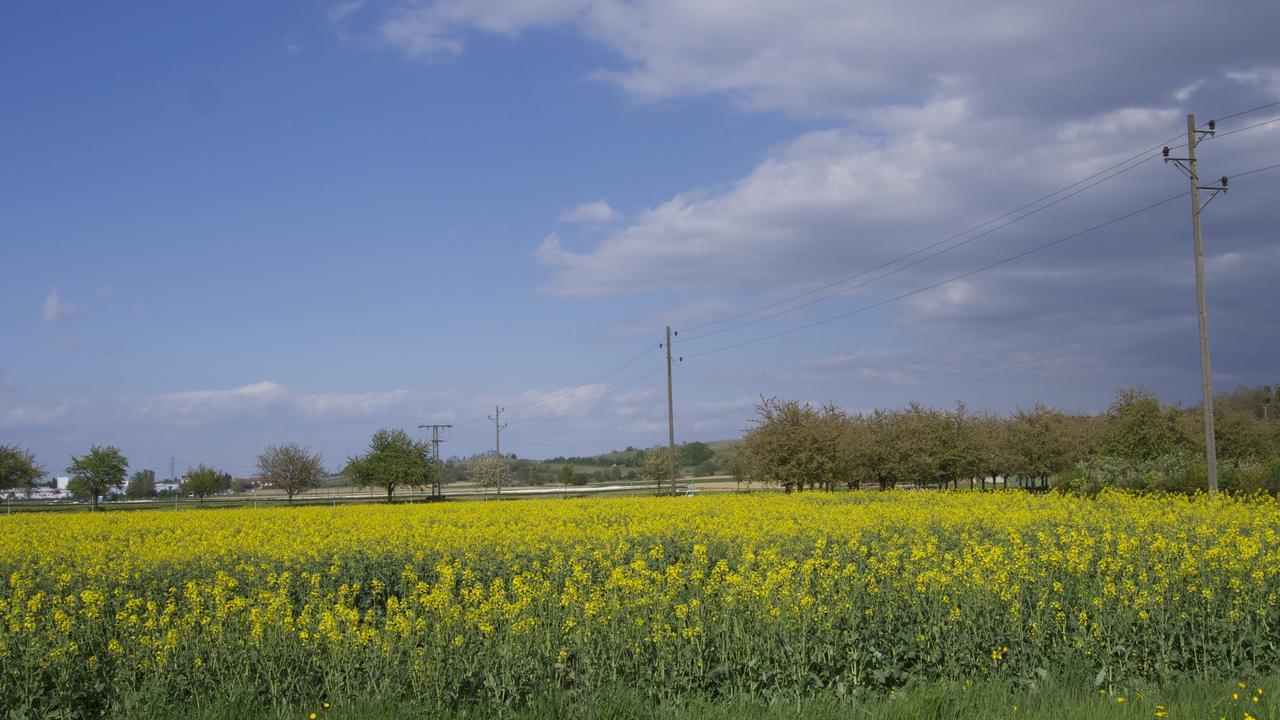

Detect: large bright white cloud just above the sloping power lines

[534,97,1179,295]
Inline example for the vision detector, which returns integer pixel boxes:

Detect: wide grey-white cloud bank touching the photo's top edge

[360,0,1280,117]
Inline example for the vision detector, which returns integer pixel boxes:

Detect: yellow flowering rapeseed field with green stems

[0,492,1280,716]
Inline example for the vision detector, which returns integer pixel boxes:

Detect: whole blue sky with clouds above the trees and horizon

[0,0,1280,474]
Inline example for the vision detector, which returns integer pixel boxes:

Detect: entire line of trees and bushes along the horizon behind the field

[0,387,1280,509]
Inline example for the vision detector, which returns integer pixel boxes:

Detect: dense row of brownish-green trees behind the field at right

[732,388,1280,492]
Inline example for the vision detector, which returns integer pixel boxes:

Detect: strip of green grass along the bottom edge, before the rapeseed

[120,676,1280,720]
